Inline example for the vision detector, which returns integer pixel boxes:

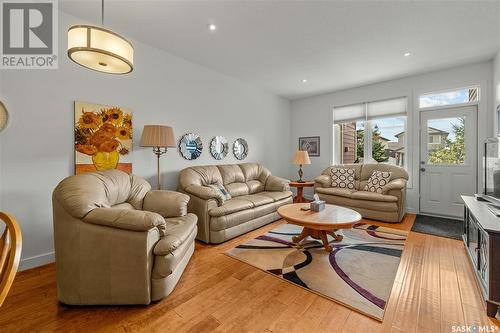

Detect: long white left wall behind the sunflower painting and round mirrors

[0,13,291,268]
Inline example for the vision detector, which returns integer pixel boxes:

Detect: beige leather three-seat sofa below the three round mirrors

[178,163,292,243]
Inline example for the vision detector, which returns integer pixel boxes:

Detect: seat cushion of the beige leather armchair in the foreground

[154,214,198,256]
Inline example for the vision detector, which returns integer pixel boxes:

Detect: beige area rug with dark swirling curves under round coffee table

[226,224,408,321]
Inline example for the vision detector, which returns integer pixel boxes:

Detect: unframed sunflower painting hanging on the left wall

[75,102,132,174]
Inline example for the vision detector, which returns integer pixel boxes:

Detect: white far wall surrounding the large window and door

[291,61,493,212]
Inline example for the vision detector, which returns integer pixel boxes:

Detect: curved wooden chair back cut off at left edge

[0,212,22,306]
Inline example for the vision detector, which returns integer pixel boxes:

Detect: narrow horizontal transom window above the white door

[419,87,479,108]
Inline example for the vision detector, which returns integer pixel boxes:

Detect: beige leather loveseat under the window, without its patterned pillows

[314,164,408,222]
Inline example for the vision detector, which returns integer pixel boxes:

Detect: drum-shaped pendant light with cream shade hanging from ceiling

[68,0,134,74]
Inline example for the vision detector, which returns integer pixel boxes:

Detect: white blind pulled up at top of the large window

[333,97,407,124]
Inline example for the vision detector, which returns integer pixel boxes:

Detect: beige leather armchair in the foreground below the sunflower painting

[52,170,197,305]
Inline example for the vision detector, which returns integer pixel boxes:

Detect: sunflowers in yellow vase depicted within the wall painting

[75,106,132,170]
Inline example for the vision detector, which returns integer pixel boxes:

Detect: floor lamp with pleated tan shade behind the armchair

[141,125,175,190]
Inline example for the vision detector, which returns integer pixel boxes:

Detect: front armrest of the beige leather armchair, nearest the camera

[83,208,165,235]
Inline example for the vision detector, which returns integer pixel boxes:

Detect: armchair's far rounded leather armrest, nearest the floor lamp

[142,191,189,217]
